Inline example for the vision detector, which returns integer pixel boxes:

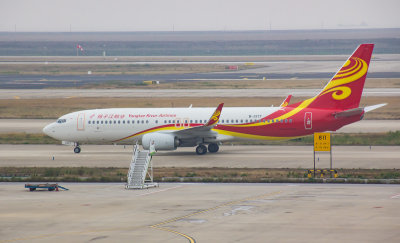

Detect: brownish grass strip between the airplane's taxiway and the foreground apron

[0,167,400,182]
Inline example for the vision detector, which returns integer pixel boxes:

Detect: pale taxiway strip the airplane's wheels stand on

[0,144,400,169]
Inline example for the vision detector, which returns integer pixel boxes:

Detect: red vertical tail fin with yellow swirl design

[308,44,374,110]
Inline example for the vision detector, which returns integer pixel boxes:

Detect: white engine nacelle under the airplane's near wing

[142,133,179,150]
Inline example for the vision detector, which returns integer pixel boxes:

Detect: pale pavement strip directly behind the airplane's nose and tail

[0,119,400,133]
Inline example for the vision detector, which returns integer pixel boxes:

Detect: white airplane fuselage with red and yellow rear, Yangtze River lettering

[44,107,361,146]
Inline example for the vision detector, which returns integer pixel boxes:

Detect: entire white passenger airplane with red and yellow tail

[43,44,385,155]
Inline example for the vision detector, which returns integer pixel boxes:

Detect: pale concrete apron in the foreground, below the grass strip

[0,183,400,243]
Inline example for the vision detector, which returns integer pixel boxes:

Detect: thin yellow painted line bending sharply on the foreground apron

[149,191,281,243]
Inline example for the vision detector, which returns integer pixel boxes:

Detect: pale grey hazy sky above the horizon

[0,0,400,31]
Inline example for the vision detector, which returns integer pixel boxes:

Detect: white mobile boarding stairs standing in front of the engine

[125,144,158,189]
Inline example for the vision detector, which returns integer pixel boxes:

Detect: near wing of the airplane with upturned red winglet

[174,103,224,137]
